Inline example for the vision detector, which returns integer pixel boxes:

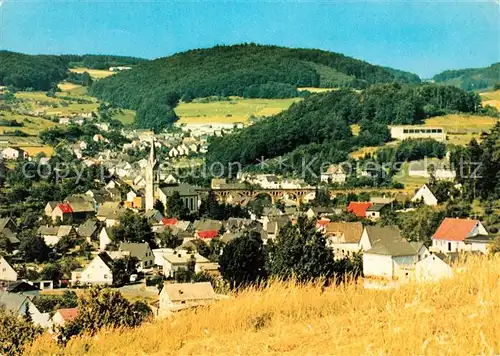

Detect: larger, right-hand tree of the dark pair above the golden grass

[269,217,335,282]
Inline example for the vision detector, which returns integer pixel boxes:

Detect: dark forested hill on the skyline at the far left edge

[0,51,68,90]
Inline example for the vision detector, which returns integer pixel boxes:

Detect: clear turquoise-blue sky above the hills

[0,0,500,78]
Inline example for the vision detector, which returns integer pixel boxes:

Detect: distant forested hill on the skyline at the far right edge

[432,62,500,90]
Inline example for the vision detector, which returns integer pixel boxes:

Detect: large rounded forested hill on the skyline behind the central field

[92,44,420,109]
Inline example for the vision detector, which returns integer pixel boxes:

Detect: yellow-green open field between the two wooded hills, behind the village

[175,98,301,124]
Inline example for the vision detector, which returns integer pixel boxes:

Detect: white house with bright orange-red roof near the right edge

[431,218,488,253]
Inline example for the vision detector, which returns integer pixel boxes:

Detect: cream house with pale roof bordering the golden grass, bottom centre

[158,282,217,316]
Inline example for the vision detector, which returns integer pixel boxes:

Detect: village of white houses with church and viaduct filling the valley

[0,105,498,330]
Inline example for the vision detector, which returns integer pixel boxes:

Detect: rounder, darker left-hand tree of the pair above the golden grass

[219,232,267,288]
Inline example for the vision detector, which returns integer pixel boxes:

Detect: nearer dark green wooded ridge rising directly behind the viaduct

[207,83,481,178]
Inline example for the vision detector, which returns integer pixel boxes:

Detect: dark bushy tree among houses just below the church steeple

[113,210,154,243]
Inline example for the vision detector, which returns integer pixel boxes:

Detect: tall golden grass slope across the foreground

[25,256,500,355]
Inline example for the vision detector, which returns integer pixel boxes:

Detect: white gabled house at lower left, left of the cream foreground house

[71,252,113,285]
